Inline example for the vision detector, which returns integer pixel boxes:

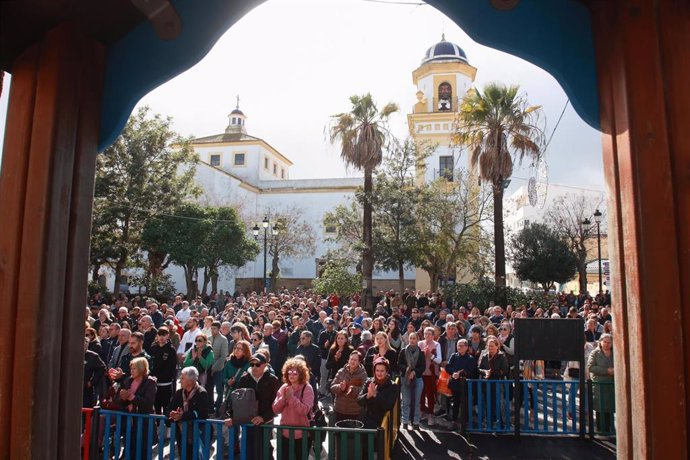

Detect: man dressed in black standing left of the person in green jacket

[151,326,177,415]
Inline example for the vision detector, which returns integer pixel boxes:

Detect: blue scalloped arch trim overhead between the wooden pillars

[98,0,599,152]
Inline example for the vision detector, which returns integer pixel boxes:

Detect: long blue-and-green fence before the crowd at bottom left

[82,408,392,460]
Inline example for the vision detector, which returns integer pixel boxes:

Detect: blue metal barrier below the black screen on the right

[466,380,585,435]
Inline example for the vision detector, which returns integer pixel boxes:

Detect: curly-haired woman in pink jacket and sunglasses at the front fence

[273,358,314,459]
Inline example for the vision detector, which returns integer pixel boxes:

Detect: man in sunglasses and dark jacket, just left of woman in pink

[223,353,280,458]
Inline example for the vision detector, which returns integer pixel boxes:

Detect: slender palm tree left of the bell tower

[329,93,398,310]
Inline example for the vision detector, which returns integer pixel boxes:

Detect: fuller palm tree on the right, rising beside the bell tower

[456,83,544,305]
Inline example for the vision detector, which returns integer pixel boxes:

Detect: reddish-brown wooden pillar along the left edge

[0,25,105,459]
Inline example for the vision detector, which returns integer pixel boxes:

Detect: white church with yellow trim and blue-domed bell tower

[161,37,477,292]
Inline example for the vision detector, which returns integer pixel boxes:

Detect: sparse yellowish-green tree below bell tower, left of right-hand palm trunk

[416,170,492,290]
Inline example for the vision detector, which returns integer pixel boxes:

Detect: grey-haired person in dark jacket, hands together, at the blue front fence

[170,366,211,460]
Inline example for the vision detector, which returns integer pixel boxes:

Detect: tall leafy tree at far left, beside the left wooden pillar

[90,107,199,295]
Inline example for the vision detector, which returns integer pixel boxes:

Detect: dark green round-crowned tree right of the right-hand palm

[510,224,577,292]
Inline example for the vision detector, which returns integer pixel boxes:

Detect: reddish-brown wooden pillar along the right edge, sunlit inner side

[589,0,690,459]
